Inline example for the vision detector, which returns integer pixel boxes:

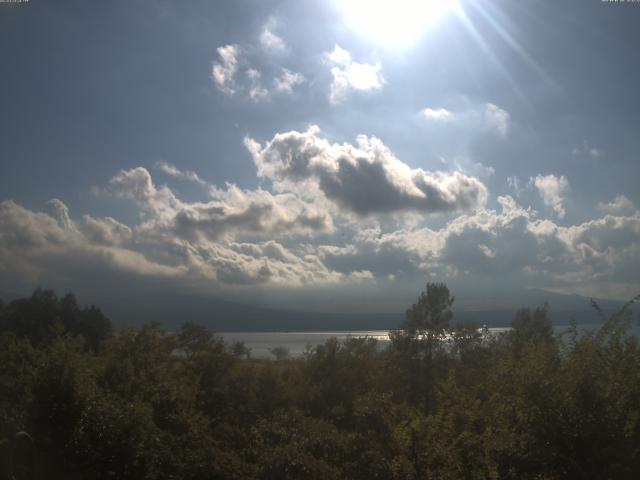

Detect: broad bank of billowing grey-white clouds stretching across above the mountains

[0,127,640,298]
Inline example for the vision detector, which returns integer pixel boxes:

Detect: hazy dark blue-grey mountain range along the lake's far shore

[0,290,636,332]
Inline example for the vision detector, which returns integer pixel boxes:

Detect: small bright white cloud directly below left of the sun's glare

[324,45,385,104]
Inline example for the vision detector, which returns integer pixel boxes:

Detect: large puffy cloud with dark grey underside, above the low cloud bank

[245,126,487,215]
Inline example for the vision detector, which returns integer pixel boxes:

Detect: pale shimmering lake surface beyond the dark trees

[219,324,640,358]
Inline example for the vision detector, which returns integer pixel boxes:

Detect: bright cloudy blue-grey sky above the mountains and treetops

[0,0,640,312]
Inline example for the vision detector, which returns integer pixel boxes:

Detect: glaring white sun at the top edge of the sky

[337,0,458,47]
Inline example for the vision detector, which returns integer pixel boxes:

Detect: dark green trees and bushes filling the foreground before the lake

[0,284,640,480]
